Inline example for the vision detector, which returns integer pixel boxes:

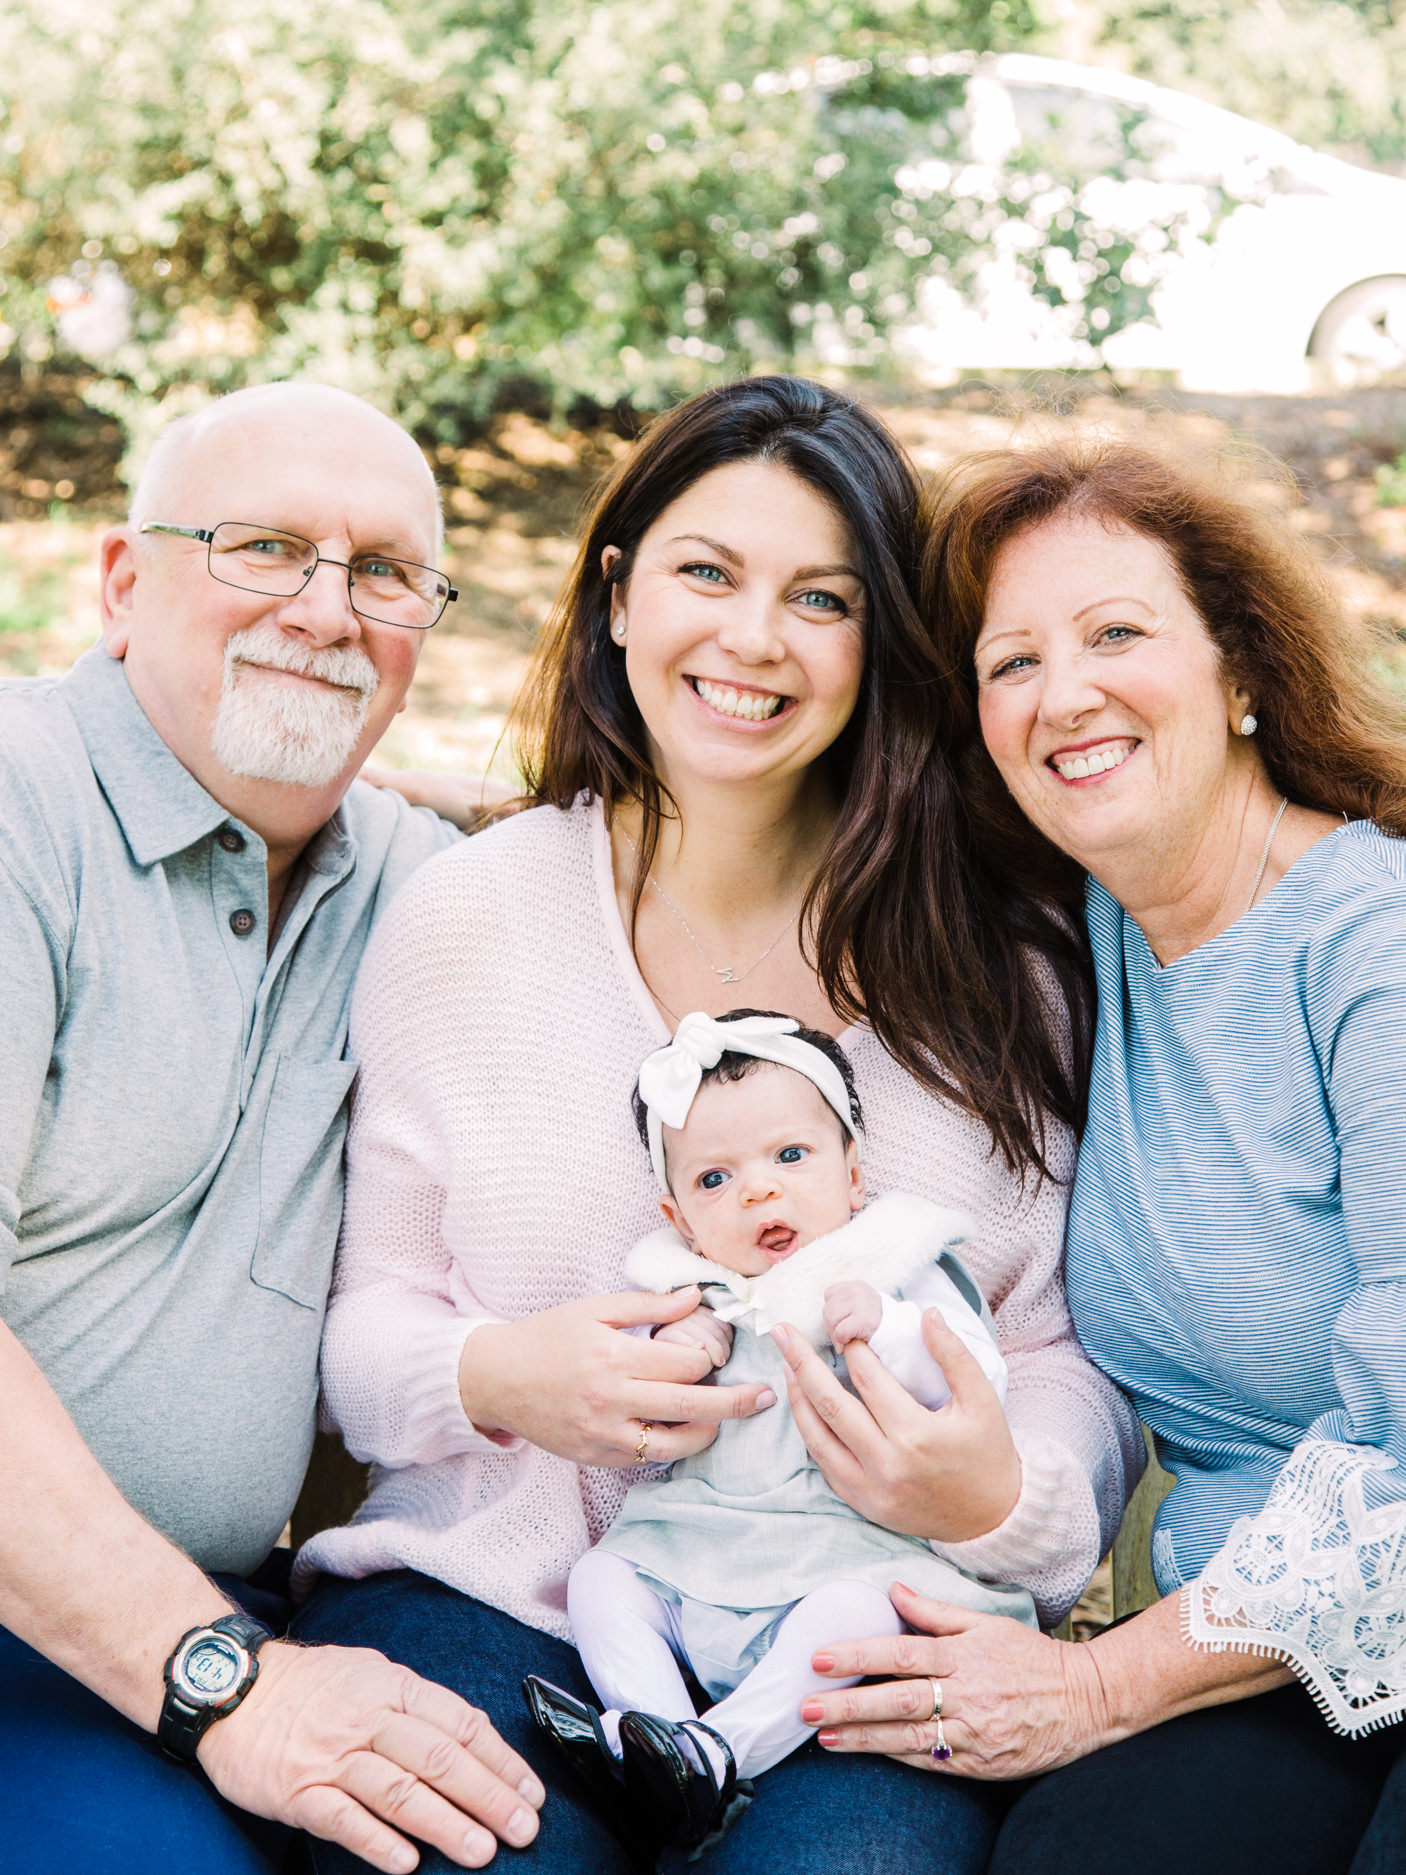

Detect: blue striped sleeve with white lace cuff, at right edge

[1183,887,1406,1733]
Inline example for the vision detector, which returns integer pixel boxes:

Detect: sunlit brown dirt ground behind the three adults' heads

[0,379,1406,776]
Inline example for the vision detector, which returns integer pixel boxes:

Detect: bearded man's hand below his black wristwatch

[199,1641,544,1871]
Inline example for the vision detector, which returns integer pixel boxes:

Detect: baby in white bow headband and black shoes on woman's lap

[525,1011,1035,1845]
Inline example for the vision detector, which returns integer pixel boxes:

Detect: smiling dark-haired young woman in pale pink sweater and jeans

[298,377,1136,1875]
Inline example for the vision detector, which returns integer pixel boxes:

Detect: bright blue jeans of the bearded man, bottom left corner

[0,1577,292,1875]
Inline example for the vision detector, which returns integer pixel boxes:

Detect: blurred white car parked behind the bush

[858,53,1406,392]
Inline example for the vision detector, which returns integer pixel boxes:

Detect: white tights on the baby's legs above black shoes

[566,1549,904,1778]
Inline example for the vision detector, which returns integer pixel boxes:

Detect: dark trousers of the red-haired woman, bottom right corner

[992,1686,1406,1875]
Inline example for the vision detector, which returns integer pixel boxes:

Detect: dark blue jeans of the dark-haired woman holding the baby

[292,1569,1005,1875]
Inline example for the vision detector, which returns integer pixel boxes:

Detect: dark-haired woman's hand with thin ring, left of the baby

[459,1286,776,1464]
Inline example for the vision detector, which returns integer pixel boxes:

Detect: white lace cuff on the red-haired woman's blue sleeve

[1183,1438,1406,1734]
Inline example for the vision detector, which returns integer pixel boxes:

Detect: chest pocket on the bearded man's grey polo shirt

[249,1056,356,1309]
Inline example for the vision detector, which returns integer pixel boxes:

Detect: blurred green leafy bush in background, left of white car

[0,0,1199,450]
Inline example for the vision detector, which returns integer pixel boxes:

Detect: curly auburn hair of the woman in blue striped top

[922,439,1406,843]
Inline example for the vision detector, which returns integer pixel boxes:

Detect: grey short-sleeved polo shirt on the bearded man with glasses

[0,651,456,1573]
